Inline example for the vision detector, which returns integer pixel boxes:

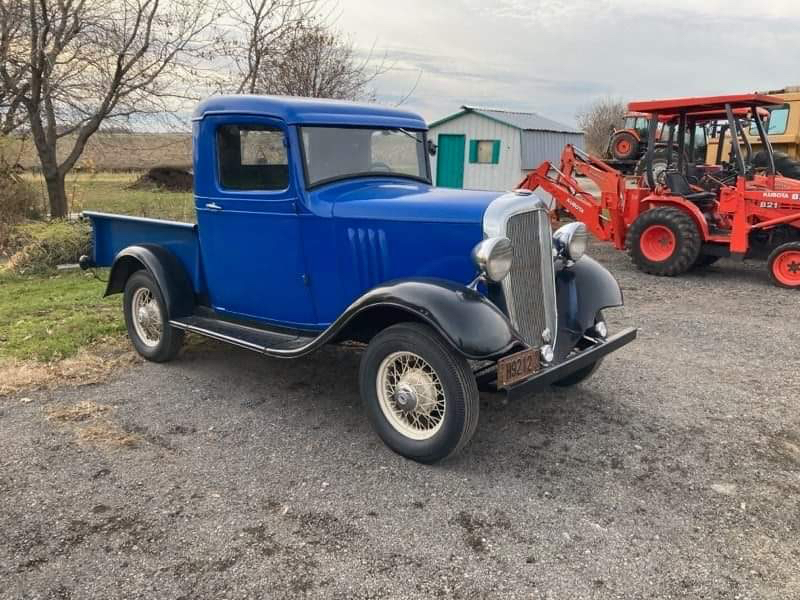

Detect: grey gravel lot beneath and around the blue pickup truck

[0,241,800,600]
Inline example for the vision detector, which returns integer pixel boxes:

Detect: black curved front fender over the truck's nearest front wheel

[331,279,522,360]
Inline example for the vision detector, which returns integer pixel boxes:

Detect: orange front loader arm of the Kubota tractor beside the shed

[517,144,626,249]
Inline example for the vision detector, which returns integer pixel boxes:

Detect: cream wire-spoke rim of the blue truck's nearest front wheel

[376,352,445,440]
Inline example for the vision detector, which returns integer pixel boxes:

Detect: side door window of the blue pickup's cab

[217,125,289,191]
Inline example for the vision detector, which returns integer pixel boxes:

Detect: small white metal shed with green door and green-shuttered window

[428,106,583,190]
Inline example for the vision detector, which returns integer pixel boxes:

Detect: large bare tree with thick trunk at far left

[0,0,218,217]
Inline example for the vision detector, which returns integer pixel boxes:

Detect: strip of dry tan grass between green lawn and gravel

[0,338,138,398]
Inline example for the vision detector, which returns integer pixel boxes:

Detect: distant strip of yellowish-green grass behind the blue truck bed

[26,172,195,222]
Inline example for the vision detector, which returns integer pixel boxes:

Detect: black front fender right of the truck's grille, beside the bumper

[555,256,623,360]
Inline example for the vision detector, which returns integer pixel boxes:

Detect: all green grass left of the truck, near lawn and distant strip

[0,172,194,362]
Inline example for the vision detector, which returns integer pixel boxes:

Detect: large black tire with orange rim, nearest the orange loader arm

[625,206,701,277]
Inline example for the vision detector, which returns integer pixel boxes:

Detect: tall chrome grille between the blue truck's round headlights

[502,209,556,348]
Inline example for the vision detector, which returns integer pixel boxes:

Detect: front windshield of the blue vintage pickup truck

[301,127,430,186]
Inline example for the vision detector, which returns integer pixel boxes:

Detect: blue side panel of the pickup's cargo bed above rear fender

[81,211,204,293]
